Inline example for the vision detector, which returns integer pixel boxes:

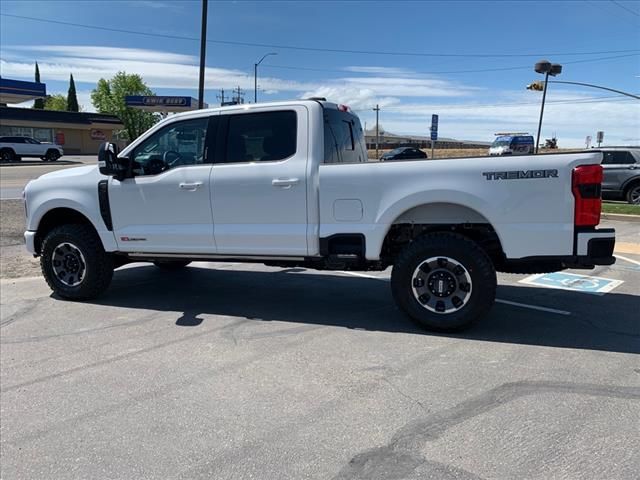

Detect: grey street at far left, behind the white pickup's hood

[0,155,98,200]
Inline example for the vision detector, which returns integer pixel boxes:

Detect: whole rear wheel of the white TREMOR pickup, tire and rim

[391,233,497,331]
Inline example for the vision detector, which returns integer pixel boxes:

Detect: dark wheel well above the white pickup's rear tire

[380,223,506,268]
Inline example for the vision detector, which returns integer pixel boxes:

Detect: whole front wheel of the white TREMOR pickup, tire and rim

[40,224,113,300]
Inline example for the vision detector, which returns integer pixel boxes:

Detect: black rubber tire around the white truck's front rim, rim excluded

[40,224,113,300]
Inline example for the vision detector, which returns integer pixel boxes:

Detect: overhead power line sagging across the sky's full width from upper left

[0,13,640,58]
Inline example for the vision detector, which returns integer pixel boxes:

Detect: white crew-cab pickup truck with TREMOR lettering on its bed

[24,99,615,330]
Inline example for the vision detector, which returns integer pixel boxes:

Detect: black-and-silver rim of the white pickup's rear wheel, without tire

[411,257,472,315]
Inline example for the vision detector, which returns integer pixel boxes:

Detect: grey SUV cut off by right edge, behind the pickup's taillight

[598,147,640,205]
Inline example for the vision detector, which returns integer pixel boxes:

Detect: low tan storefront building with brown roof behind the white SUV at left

[0,107,124,154]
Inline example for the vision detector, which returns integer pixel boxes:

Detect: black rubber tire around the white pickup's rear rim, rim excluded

[391,232,497,332]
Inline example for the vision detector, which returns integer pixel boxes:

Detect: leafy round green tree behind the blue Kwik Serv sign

[91,72,158,140]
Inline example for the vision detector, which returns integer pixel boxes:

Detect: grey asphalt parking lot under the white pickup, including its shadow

[0,215,640,479]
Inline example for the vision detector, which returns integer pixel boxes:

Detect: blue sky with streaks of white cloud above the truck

[0,0,640,147]
